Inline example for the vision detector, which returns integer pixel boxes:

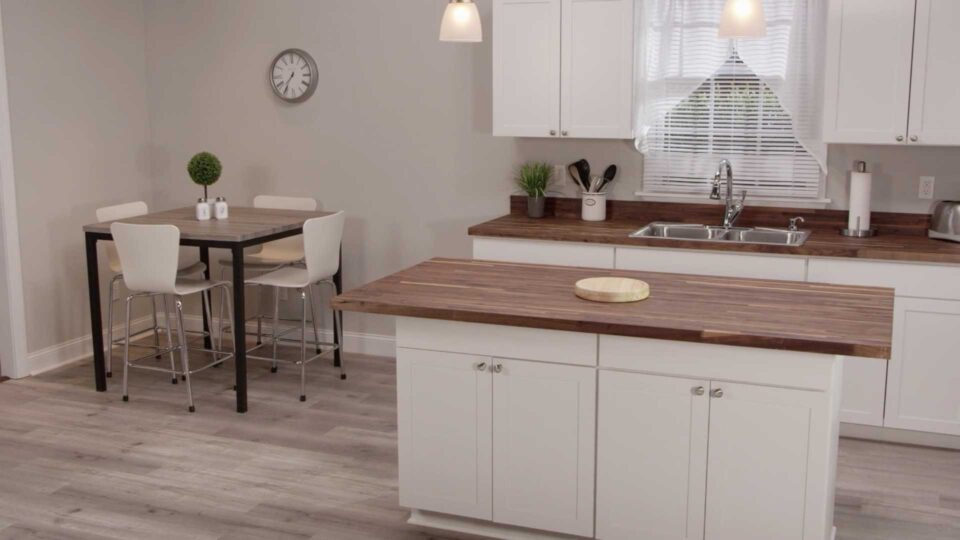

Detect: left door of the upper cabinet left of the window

[493,0,561,137]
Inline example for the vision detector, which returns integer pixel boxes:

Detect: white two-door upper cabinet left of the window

[493,0,634,139]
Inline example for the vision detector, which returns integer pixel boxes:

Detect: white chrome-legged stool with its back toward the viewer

[110,223,236,412]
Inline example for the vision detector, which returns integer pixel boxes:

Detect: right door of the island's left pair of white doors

[492,358,596,536]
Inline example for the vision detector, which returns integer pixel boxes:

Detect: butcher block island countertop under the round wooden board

[333,258,893,359]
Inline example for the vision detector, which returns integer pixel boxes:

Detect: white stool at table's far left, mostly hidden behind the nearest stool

[97,201,207,384]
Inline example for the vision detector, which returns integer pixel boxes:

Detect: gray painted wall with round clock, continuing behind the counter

[0,0,960,358]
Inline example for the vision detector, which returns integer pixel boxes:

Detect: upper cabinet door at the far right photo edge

[909,0,960,145]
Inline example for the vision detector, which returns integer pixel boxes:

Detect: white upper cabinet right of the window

[824,0,960,145]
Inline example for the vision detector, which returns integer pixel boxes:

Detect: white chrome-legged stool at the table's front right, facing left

[247,212,347,401]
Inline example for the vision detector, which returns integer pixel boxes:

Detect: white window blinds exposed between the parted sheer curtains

[643,53,822,199]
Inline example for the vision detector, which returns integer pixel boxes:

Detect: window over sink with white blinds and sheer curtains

[636,0,826,202]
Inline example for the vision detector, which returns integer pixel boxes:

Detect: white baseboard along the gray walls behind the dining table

[21,315,396,376]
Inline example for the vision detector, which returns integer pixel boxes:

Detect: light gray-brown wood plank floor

[0,344,960,540]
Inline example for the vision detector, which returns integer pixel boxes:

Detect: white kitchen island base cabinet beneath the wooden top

[397,318,844,540]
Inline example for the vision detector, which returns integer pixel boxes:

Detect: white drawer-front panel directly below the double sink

[616,248,806,281]
